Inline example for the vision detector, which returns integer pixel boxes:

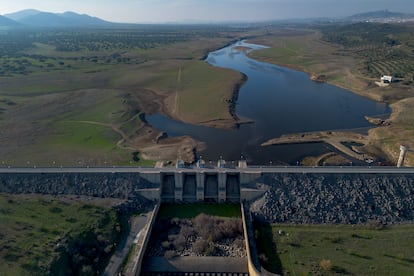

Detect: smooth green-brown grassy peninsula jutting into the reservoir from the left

[142,60,241,123]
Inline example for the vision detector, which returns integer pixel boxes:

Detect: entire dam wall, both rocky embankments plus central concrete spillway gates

[0,168,414,224]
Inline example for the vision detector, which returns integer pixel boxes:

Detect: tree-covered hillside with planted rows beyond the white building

[322,23,414,85]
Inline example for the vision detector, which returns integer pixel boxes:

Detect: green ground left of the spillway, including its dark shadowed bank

[0,194,120,275]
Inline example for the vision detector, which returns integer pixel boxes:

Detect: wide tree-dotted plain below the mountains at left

[0,26,243,76]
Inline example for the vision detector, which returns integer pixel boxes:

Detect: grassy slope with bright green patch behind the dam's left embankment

[3,84,142,165]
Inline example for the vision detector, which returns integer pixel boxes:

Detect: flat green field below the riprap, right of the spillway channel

[256,224,414,275]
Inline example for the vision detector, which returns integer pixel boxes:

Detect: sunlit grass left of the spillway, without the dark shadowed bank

[0,194,116,275]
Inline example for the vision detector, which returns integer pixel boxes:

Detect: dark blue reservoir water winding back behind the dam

[147,41,390,165]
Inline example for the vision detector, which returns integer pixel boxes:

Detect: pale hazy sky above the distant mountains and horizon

[0,0,414,23]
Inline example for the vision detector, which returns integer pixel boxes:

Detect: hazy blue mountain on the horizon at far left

[5,10,115,27]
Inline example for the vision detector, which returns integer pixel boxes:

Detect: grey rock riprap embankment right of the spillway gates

[251,174,414,224]
